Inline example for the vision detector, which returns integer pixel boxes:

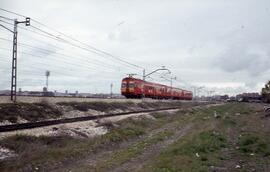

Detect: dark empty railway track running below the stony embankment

[0,107,180,133]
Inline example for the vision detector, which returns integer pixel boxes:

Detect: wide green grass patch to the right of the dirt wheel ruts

[140,103,270,172]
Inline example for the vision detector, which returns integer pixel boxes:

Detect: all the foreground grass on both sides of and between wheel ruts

[0,103,270,172]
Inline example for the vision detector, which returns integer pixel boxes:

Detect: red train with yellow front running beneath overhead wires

[121,77,193,100]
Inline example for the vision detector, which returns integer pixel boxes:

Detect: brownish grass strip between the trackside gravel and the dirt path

[0,108,179,171]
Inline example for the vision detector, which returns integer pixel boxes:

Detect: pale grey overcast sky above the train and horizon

[0,0,270,94]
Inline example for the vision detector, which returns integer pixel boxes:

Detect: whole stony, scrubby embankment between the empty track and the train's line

[0,101,200,125]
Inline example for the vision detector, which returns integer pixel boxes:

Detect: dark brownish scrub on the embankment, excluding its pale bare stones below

[0,101,188,123]
